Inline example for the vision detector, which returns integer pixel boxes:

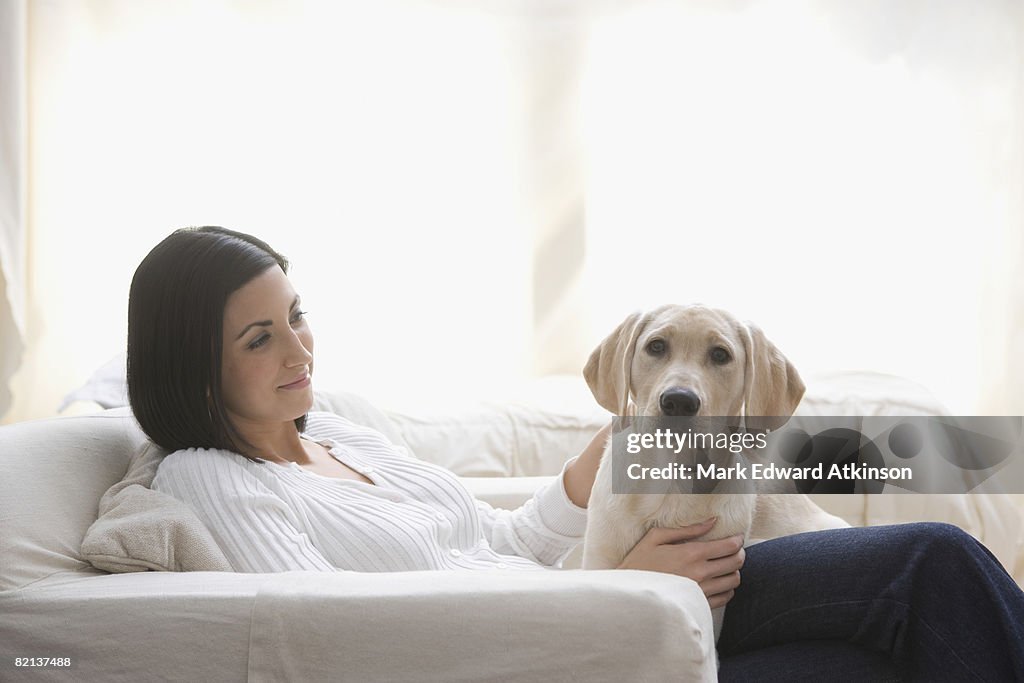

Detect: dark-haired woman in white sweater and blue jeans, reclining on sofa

[128,227,1024,680]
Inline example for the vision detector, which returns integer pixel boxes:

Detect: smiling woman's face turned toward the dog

[221,265,313,429]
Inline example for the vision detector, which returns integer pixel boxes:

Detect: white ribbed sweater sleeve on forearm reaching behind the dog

[476,459,587,567]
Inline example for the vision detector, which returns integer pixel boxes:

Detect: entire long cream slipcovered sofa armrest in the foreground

[0,569,716,682]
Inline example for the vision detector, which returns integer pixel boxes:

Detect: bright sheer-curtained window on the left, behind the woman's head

[15,0,531,415]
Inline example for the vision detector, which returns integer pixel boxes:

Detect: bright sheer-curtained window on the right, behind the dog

[585,0,1024,414]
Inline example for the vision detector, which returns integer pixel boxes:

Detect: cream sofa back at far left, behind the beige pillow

[0,409,147,591]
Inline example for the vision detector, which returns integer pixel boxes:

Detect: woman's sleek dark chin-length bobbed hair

[128,226,306,457]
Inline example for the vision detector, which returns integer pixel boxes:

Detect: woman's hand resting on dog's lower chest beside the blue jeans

[618,519,745,608]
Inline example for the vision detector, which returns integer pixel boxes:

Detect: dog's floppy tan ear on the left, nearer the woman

[583,311,646,415]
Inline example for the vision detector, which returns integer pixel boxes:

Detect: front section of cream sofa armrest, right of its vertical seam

[249,570,716,682]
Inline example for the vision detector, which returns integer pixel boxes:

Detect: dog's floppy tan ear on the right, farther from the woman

[739,323,805,429]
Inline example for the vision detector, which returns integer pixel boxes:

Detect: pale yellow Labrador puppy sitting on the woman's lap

[583,305,849,641]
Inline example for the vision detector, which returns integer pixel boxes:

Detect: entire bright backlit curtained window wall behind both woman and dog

[0,0,1024,421]
